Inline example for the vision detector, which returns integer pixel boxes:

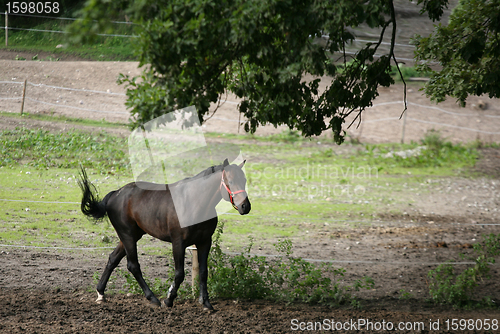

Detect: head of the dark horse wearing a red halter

[220,159,251,215]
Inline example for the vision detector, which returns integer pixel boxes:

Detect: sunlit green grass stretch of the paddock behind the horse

[0,116,477,252]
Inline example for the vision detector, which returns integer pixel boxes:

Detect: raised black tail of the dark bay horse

[78,167,114,220]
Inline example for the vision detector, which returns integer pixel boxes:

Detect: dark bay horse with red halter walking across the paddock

[78,159,251,310]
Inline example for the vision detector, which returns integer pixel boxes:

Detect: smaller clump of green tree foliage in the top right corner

[415,0,500,106]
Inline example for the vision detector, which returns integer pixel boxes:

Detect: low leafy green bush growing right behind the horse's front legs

[208,224,374,306]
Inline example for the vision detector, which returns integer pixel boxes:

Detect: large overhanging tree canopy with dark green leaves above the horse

[69,0,454,143]
